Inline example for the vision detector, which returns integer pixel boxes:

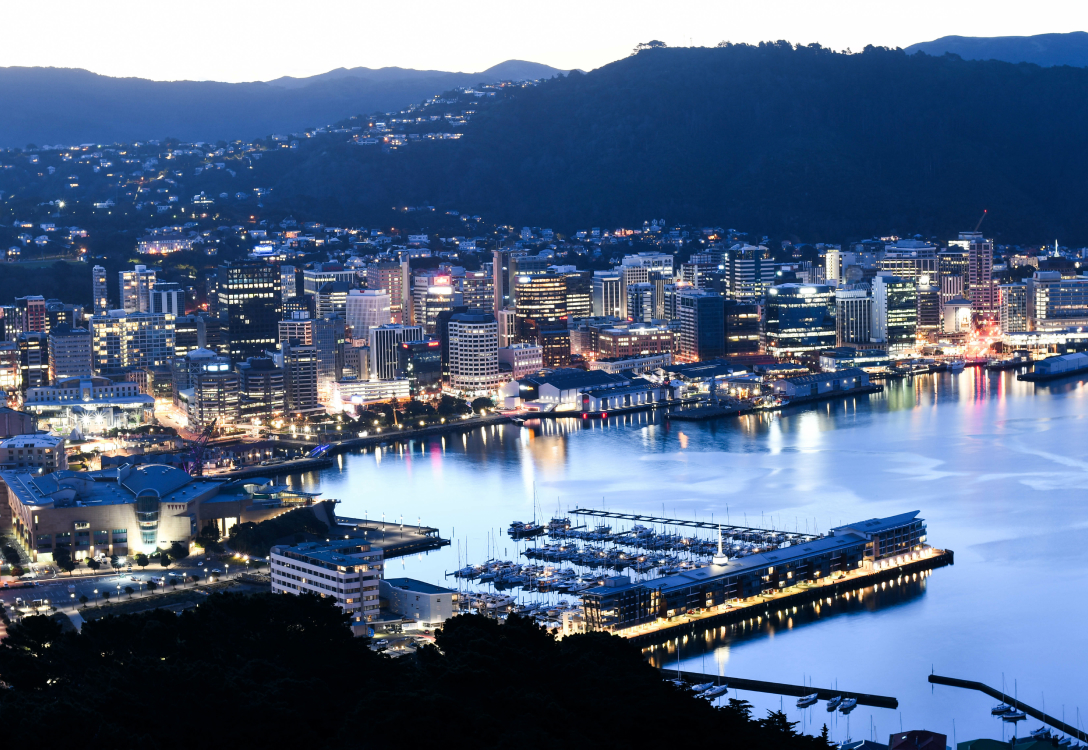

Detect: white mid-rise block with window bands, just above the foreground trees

[270,540,384,623]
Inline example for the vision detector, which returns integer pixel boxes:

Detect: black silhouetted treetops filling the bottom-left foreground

[0,594,829,750]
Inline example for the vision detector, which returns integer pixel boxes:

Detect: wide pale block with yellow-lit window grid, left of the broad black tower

[90,310,175,376]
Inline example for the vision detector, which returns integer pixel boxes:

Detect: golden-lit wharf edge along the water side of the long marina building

[614,550,955,646]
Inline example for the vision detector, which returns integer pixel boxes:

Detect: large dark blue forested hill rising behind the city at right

[270,42,1088,242]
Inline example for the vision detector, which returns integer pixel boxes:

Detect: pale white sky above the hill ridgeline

[6,0,1088,82]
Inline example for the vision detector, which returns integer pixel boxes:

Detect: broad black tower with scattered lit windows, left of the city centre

[217,261,282,361]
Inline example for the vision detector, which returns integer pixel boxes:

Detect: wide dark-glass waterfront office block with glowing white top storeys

[765,284,831,357]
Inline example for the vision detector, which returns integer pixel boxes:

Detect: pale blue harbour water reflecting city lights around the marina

[292,369,1088,745]
